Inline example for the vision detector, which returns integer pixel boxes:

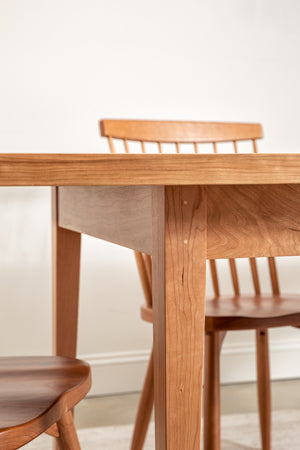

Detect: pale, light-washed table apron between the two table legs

[58,186,152,253]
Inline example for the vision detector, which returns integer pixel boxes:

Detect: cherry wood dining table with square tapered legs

[0,154,300,450]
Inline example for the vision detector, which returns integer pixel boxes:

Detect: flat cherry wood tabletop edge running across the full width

[0,153,300,186]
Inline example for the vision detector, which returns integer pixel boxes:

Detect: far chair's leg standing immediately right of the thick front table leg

[203,332,225,450]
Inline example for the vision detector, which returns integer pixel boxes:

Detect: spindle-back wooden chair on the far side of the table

[100,120,300,450]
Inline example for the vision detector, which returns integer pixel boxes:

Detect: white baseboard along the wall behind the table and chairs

[80,339,300,396]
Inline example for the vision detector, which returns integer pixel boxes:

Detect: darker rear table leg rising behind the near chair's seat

[52,188,81,357]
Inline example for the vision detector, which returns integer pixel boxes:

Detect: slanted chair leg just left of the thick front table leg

[130,350,154,450]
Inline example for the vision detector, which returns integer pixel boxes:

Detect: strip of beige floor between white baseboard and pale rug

[75,380,300,428]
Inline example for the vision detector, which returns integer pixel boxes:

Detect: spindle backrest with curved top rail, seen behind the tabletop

[100,119,279,307]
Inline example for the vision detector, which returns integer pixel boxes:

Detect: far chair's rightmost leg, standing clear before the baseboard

[256,330,271,450]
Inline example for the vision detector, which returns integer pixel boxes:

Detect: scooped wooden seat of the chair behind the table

[205,295,300,331]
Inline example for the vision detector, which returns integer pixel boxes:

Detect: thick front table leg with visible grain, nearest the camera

[152,186,206,450]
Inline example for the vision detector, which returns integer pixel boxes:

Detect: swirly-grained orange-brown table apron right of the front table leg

[207,184,300,260]
